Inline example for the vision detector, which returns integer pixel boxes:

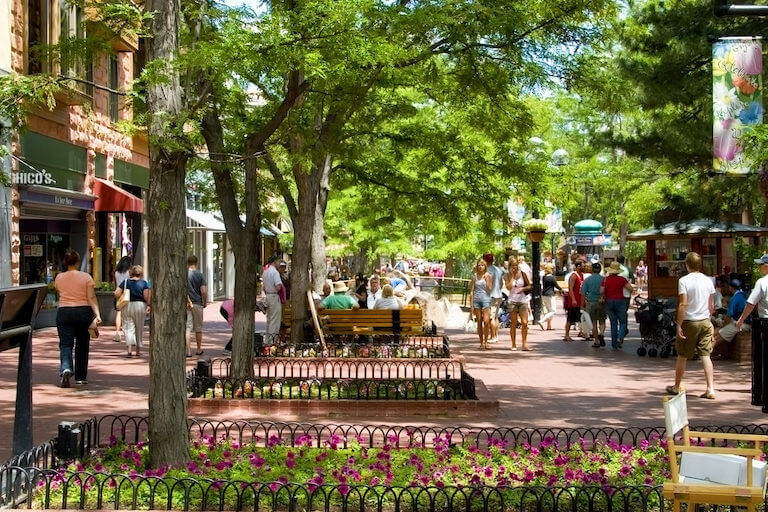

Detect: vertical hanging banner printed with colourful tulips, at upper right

[712,37,763,174]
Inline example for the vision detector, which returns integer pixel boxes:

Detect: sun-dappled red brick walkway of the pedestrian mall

[0,305,765,460]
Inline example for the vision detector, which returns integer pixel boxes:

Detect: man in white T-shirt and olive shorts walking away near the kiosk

[666,252,715,400]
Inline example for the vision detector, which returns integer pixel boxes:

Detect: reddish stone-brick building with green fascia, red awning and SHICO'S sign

[6,0,149,306]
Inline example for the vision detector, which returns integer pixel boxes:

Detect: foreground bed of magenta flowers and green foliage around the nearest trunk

[33,434,668,510]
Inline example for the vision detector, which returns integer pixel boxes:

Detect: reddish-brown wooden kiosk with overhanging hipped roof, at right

[627,219,768,297]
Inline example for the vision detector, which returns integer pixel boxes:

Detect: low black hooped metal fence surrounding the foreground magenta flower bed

[0,416,768,512]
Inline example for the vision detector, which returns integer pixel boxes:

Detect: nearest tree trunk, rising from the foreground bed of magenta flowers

[147,0,189,467]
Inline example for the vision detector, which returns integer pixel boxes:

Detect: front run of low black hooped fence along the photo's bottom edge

[0,467,671,512]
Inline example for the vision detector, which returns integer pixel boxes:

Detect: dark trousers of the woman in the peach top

[56,306,96,380]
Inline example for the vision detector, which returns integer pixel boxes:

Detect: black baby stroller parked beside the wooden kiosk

[635,296,677,357]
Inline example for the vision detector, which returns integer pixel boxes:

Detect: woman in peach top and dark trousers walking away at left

[54,249,101,388]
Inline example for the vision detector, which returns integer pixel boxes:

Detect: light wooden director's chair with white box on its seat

[662,393,768,512]
